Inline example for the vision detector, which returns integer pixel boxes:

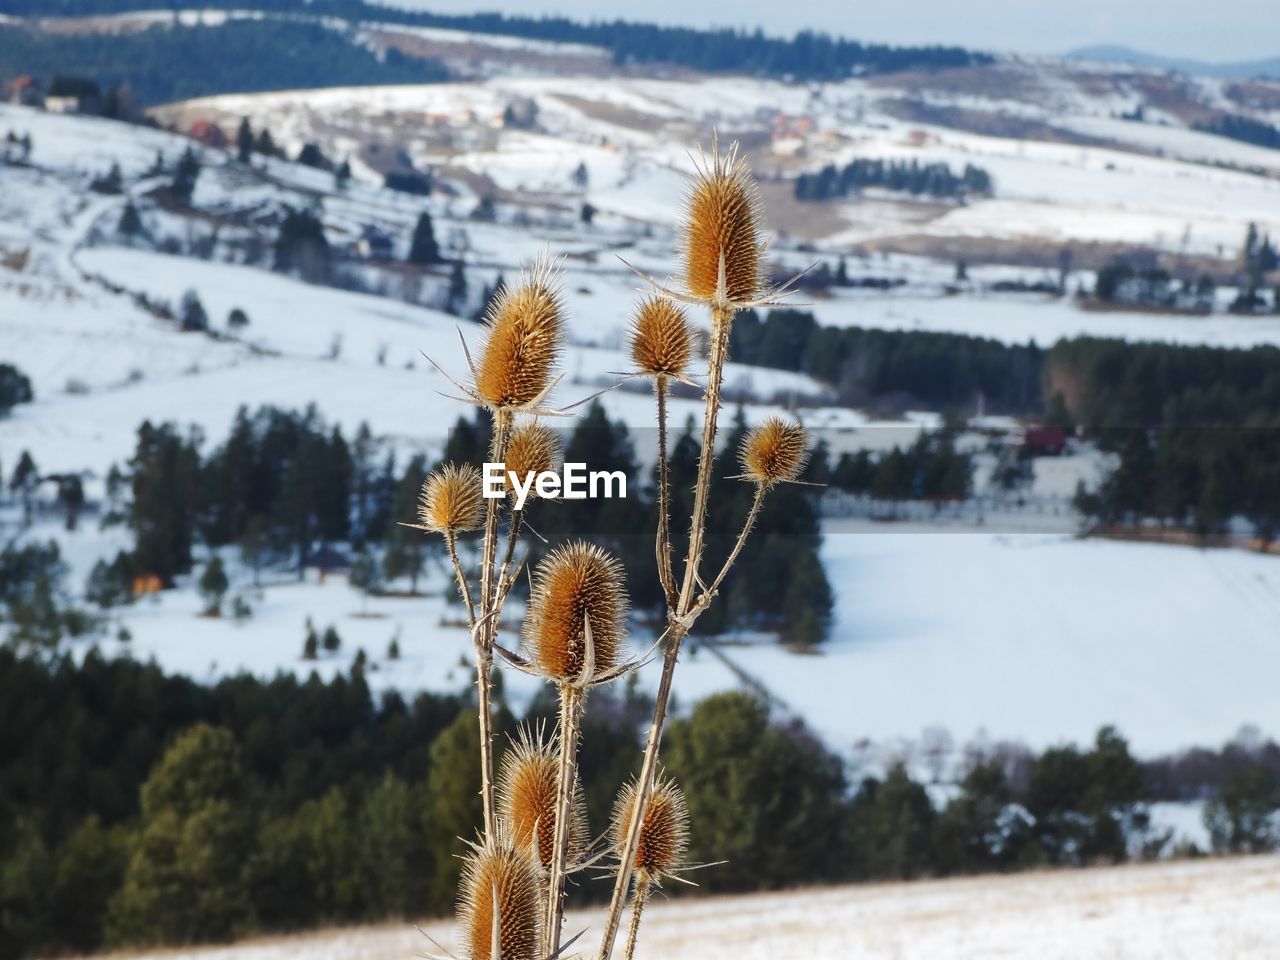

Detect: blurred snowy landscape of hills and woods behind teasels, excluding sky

[0,0,1280,957]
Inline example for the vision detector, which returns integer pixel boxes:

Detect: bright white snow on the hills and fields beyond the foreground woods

[0,73,1280,768]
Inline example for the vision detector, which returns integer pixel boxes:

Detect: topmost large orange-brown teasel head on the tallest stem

[681,142,764,303]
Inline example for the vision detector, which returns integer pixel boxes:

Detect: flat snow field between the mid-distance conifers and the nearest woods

[55,521,1280,756]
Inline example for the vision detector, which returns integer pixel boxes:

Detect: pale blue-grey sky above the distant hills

[387,0,1280,63]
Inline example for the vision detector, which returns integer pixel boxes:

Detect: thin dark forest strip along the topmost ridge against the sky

[2,0,993,86]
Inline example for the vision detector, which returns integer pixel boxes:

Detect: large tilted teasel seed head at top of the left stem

[475,259,564,407]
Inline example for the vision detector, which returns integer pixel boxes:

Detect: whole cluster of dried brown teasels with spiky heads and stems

[412,141,805,960]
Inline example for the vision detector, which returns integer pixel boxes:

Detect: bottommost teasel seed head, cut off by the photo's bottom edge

[458,836,544,960]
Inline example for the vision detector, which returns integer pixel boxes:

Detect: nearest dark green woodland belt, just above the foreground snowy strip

[0,648,1280,957]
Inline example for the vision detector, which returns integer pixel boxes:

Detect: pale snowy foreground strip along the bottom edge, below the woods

[97,856,1280,960]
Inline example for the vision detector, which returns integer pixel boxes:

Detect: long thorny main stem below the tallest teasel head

[599,302,733,960]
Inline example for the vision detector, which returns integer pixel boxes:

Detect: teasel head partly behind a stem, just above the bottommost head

[498,731,586,870]
